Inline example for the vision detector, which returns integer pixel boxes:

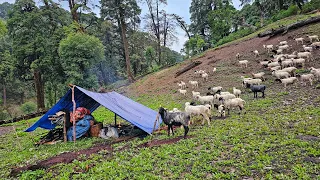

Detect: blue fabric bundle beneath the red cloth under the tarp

[67,115,93,141]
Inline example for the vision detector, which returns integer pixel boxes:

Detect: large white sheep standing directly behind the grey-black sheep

[185,102,211,125]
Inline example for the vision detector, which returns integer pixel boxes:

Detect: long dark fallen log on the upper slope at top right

[258,16,320,38]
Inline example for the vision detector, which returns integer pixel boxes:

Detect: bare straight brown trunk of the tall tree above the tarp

[120,9,134,82]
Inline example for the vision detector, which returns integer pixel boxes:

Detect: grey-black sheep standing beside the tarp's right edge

[159,107,190,138]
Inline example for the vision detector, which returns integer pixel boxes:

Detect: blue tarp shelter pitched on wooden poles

[25,86,162,134]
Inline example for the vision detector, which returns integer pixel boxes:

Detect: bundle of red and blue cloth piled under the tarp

[67,107,94,141]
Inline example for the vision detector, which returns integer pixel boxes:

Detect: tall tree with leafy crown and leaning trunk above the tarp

[101,0,141,82]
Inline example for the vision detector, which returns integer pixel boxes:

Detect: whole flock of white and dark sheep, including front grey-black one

[159,35,320,137]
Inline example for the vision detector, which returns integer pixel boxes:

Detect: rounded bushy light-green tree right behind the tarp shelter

[59,33,104,87]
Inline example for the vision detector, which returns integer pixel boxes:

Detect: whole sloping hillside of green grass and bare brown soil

[0,13,320,179]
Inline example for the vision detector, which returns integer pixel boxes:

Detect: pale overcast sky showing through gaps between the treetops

[0,0,240,52]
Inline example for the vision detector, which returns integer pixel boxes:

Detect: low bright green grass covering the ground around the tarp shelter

[0,91,320,179]
